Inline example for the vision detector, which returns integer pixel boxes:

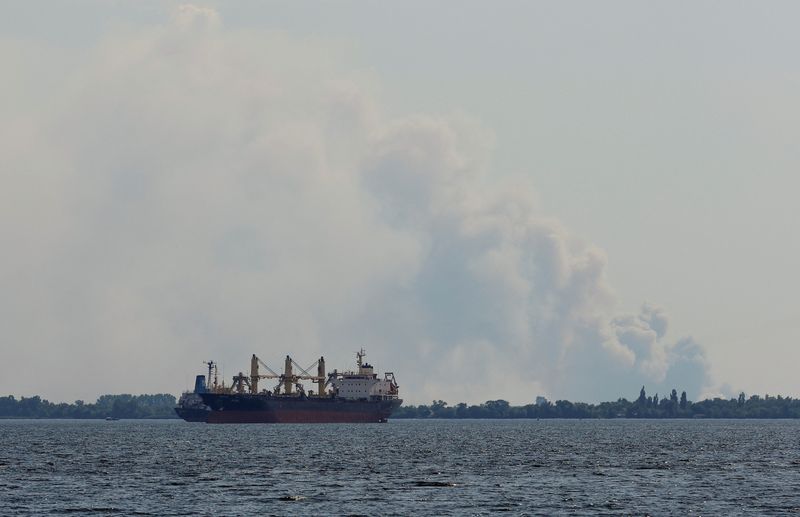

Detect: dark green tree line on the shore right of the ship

[392,387,800,418]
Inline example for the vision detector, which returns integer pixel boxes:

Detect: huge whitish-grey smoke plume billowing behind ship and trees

[0,6,709,403]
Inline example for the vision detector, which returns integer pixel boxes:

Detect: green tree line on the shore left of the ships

[0,393,177,418]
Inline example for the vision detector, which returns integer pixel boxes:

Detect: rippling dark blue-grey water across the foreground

[0,420,800,516]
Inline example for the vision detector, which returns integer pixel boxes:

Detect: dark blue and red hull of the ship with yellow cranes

[201,393,402,424]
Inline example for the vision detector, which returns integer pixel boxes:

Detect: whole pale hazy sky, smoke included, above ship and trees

[0,0,800,404]
